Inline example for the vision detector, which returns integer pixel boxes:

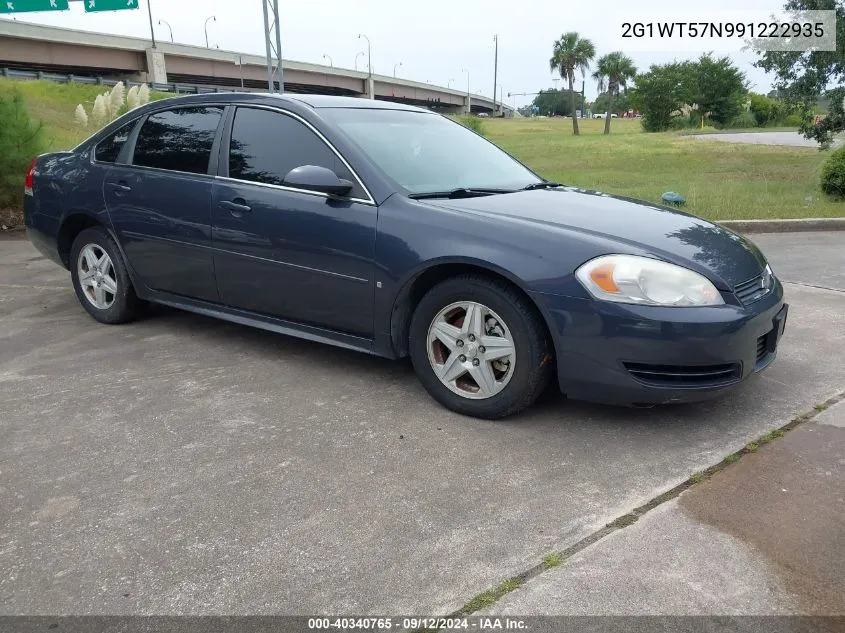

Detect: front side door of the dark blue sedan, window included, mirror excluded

[213,107,378,337]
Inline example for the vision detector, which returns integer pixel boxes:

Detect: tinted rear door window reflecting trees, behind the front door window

[132,107,223,174]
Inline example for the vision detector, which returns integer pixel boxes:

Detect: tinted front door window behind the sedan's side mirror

[229,108,352,189]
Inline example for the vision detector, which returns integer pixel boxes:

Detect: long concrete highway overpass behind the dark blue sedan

[0,19,513,116]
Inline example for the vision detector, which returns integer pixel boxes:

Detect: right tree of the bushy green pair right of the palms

[689,54,748,126]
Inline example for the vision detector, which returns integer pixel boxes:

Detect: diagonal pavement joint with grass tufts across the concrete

[445,390,845,618]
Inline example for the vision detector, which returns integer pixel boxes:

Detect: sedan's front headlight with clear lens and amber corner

[575,255,725,306]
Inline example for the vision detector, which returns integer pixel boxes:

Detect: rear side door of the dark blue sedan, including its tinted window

[103,105,224,301]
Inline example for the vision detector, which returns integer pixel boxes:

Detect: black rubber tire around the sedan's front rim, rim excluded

[409,274,553,420]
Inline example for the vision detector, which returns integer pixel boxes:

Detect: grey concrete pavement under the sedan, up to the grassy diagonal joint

[0,233,845,615]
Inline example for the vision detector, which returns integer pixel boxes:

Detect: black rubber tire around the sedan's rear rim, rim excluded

[69,227,141,325]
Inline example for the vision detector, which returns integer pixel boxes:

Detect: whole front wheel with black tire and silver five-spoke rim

[410,275,551,419]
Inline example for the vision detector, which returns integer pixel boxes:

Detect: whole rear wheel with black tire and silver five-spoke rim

[70,228,139,324]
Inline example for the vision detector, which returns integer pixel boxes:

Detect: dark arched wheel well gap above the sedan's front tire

[390,264,551,358]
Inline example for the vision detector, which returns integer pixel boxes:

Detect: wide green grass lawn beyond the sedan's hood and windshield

[484,118,845,220]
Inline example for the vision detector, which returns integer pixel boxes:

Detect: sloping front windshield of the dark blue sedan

[321,108,540,193]
